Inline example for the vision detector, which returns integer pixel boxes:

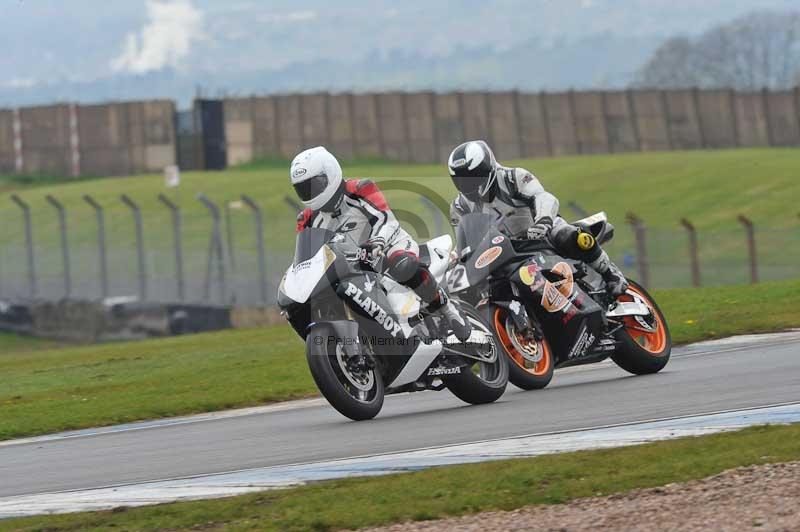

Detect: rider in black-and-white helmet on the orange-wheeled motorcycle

[447,140,628,298]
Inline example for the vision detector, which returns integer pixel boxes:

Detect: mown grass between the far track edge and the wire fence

[0,281,800,439]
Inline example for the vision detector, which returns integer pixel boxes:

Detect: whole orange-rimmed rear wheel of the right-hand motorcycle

[611,281,672,375]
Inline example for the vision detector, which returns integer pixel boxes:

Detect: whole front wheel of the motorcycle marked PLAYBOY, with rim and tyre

[306,325,384,421]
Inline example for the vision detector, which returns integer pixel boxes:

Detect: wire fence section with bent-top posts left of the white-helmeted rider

[0,194,294,305]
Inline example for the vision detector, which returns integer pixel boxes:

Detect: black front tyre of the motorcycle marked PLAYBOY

[306,325,384,421]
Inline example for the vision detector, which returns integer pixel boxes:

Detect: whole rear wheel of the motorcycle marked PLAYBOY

[442,301,508,405]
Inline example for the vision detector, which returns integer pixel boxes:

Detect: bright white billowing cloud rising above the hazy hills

[111,0,204,74]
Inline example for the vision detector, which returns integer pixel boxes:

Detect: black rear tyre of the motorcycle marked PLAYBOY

[442,301,508,405]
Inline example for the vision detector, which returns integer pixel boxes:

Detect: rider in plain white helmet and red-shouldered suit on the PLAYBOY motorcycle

[289,146,471,342]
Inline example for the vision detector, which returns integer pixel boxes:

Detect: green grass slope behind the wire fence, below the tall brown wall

[0,149,800,287]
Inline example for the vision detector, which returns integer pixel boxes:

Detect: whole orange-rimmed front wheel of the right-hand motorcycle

[483,305,555,390]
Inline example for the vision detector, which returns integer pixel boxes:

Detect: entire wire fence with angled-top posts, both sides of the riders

[0,194,800,306]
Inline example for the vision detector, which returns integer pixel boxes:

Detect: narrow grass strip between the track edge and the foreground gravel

[0,425,800,531]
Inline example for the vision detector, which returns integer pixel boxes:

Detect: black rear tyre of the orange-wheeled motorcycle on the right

[611,280,672,375]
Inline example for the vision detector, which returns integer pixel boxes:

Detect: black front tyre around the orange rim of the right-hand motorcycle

[481,304,555,390]
